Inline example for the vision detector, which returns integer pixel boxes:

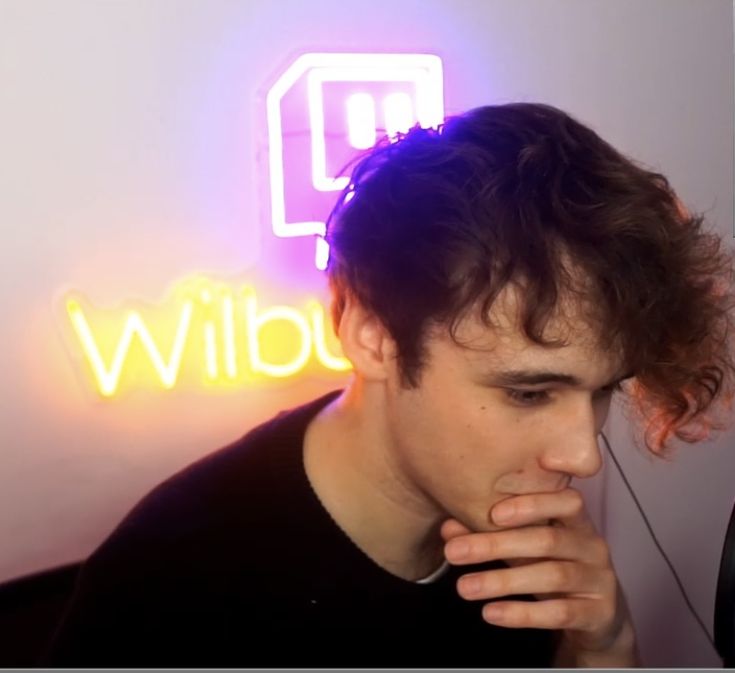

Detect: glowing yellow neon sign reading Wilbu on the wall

[65,278,351,397]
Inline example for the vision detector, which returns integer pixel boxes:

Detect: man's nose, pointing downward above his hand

[541,402,602,479]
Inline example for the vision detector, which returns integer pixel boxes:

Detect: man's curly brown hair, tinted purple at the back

[327,103,735,455]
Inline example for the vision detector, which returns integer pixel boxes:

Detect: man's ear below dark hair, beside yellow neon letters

[339,297,397,380]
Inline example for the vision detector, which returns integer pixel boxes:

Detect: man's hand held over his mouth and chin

[441,488,640,667]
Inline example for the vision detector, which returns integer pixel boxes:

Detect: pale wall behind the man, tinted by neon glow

[0,0,735,666]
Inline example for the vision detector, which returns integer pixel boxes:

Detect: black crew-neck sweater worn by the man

[39,391,553,668]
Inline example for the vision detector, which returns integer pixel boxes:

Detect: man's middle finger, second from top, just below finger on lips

[444,526,609,566]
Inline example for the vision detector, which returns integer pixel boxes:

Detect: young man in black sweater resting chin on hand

[42,103,735,668]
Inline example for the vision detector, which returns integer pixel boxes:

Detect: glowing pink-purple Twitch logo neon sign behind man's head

[266,54,444,270]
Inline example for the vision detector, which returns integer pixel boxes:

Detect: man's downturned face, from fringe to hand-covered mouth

[386,291,626,531]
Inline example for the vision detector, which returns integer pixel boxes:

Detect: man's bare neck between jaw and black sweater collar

[304,385,444,581]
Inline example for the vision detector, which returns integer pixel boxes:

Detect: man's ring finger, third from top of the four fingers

[457,561,616,600]
